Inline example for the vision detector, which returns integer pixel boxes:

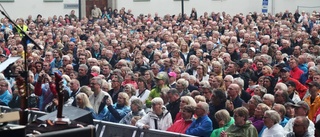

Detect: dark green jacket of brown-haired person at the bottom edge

[226,120,258,137]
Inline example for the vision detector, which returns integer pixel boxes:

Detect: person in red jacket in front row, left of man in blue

[167,105,196,134]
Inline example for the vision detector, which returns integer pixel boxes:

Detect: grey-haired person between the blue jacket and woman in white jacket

[119,99,146,126]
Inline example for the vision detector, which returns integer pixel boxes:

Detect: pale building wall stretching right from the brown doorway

[116,0,320,16]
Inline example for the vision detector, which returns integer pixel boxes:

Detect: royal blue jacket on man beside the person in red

[186,115,213,137]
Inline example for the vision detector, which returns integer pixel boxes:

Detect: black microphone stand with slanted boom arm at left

[0,10,42,125]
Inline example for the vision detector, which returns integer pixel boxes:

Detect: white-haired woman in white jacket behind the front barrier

[136,97,172,130]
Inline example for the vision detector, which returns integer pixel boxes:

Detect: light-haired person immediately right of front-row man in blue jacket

[210,109,234,137]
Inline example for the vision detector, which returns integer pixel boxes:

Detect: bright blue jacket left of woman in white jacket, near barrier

[104,103,131,123]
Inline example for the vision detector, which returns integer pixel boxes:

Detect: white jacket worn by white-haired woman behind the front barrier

[136,107,172,130]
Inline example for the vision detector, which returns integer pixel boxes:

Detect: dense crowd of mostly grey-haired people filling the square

[0,6,320,137]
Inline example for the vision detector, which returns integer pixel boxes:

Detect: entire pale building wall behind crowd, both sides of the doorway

[0,0,320,19]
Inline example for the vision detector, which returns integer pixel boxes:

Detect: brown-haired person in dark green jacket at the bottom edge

[220,107,258,137]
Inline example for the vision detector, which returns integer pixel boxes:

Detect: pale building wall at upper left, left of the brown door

[0,0,79,19]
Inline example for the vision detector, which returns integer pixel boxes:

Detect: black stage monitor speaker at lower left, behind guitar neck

[37,106,93,124]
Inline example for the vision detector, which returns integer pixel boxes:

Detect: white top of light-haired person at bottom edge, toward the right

[261,124,286,137]
